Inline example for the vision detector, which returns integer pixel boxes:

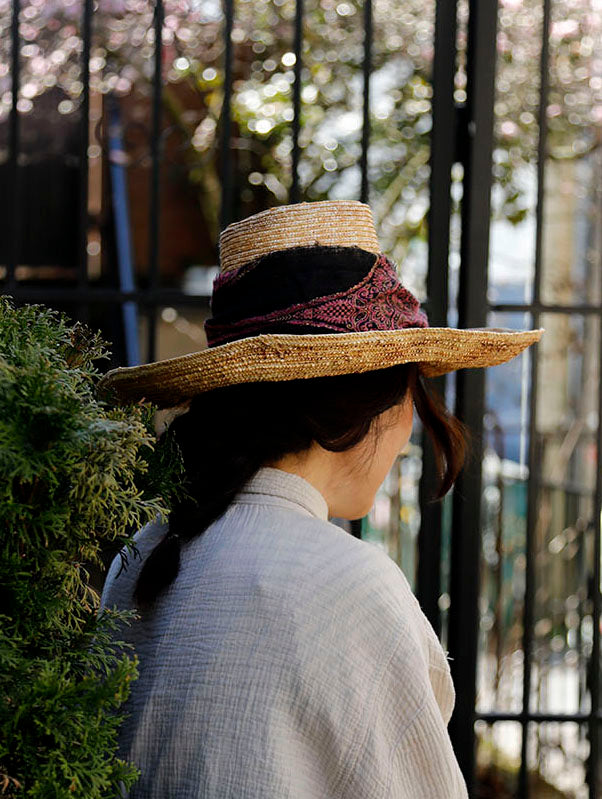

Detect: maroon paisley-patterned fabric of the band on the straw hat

[205,255,428,347]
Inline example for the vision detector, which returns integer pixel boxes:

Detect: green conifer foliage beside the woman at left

[0,298,182,799]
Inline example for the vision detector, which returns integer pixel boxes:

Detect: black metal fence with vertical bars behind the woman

[2,0,602,797]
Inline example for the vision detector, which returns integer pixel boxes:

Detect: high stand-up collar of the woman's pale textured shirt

[234,467,328,521]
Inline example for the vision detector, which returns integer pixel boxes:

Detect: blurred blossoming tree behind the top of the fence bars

[0,0,602,268]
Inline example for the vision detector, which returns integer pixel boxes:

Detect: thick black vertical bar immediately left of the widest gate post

[416,0,457,635]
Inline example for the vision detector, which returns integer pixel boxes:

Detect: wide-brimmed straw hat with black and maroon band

[99,202,543,408]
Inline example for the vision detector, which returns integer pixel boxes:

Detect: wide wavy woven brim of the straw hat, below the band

[99,327,543,408]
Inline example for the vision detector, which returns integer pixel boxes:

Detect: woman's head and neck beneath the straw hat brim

[174,366,416,519]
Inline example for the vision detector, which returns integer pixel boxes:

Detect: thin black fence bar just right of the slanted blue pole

[147,0,165,361]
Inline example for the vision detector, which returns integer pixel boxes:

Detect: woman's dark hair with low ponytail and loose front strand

[134,364,466,607]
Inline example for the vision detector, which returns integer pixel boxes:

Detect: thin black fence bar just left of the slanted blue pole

[77,0,93,322]
